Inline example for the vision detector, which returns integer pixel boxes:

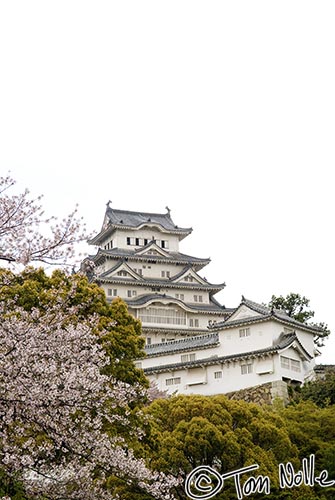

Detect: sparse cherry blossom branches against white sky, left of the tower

[0,176,87,265]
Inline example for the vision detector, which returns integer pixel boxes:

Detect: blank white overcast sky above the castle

[0,0,335,363]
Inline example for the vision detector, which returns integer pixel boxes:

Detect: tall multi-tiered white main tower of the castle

[89,202,231,344]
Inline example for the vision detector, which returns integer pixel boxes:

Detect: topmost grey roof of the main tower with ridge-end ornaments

[89,203,192,245]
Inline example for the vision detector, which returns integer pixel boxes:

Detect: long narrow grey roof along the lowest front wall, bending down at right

[144,334,312,374]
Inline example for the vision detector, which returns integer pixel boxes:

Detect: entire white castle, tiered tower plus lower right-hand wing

[89,203,319,395]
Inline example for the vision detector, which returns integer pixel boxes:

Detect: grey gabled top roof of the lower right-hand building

[212,296,326,334]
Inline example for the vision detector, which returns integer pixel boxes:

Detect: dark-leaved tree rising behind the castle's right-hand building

[268,293,330,347]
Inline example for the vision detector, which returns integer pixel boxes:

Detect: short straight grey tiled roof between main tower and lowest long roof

[145,333,219,357]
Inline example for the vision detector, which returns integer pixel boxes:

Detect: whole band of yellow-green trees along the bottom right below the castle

[141,395,335,500]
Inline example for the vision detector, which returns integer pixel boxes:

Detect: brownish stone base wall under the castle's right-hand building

[226,380,289,405]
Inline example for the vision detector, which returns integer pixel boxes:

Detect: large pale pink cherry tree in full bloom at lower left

[0,298,180,500]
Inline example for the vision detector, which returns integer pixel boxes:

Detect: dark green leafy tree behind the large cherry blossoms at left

[0,267,148,387]
